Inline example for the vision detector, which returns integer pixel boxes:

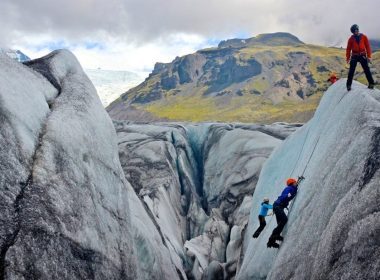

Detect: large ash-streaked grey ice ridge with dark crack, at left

[0,51,138,279]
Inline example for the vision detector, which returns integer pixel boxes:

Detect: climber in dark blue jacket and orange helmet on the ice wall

[267,178,298,248]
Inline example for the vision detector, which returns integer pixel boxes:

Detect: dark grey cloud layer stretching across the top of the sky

[0,0,380,45]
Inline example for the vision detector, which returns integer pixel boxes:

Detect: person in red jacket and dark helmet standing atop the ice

[346,24,375,91]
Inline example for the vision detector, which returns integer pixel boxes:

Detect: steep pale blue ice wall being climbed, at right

[237,80,380,279]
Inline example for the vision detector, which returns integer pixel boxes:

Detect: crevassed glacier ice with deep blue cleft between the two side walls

[115,121,299,279]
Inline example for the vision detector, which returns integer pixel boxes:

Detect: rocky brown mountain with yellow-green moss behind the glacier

[107,33,380,123]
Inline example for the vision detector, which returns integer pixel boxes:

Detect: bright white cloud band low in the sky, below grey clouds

[13,33,212,76]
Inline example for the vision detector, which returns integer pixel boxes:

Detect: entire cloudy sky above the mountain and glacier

[0,0,380,72]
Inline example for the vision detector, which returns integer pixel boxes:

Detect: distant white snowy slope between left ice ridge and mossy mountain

[85,69,143,107]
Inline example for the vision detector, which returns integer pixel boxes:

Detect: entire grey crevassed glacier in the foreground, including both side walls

[0,50,380,280]
